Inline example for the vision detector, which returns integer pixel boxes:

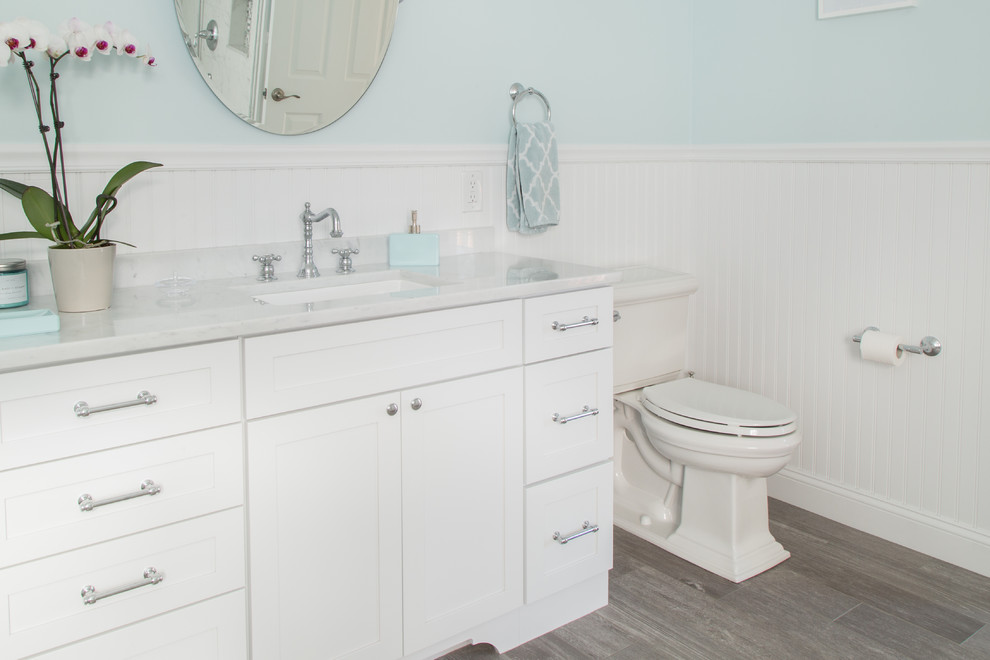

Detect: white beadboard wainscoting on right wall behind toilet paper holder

[689,150,990,575]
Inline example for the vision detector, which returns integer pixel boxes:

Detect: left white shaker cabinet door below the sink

[248,395,402,660]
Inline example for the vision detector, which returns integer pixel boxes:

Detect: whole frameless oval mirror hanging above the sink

[175,0,399,135]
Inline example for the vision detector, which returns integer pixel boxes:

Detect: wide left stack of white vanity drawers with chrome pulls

[0,341,246,660]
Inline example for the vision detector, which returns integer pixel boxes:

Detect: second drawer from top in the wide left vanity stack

[0,425,244,568]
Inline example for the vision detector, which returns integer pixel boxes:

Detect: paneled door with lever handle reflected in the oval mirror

[261,0,395,135]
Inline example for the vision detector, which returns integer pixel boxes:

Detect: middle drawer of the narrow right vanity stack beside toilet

[526,349,613,484]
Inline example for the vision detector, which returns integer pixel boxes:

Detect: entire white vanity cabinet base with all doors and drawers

[0,280,612,660]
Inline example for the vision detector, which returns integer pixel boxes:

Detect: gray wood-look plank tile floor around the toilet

[445,500,990,660]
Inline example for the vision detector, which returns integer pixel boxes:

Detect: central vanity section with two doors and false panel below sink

[245,301,523,660]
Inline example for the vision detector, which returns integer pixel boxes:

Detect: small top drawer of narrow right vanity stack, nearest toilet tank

[523,287,612,364]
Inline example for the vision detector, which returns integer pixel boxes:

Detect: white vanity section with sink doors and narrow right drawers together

[244,288,612,660]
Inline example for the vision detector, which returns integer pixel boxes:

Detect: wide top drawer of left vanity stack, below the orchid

[0,341,240,470]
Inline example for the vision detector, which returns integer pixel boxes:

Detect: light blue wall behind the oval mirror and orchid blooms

[0,0,691,145]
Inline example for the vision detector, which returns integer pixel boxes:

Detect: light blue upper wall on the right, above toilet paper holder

[692,0,990,144]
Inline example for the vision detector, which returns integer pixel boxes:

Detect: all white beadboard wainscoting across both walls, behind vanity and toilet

[0,143,990,575]
